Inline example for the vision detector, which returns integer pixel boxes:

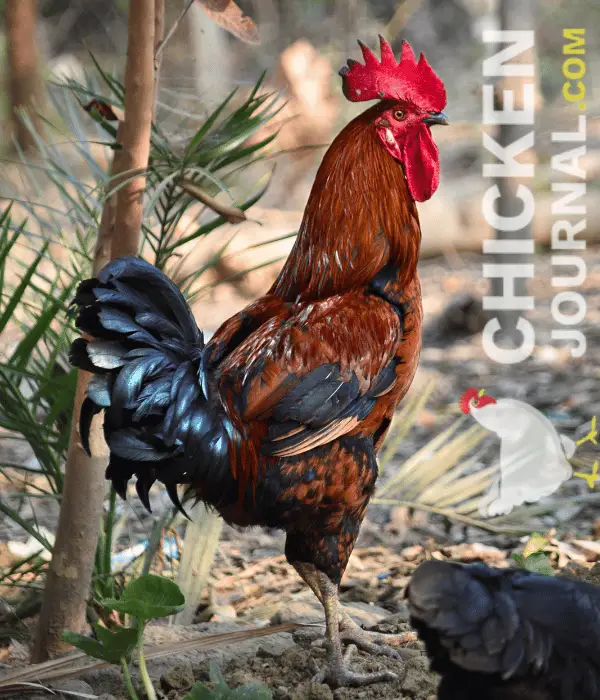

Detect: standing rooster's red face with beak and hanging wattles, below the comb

[375,100,448,202]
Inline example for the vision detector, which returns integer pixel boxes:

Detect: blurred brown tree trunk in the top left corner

[5,0,41,150]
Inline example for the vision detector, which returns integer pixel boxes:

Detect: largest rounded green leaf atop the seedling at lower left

[101,574,185,621]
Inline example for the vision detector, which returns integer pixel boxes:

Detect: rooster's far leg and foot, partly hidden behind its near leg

[294,562,417,659]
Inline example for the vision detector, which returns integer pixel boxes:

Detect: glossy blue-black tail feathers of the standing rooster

[70,257,237,508]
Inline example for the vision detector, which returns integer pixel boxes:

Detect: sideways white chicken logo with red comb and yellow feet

[459,389,598,517]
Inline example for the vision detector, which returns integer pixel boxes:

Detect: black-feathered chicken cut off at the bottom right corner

[407,560,600,700]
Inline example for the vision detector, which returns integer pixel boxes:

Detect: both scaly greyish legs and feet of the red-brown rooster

[294,562,400,688]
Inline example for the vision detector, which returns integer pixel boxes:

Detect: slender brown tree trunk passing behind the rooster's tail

[31,0,164,662]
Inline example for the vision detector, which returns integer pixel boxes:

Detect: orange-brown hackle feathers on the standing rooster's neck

[271,103,421,300]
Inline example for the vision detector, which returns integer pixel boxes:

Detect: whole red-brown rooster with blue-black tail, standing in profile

[71,39,448,687]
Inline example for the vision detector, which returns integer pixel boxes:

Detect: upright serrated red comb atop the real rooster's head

[340,36,446,112]
